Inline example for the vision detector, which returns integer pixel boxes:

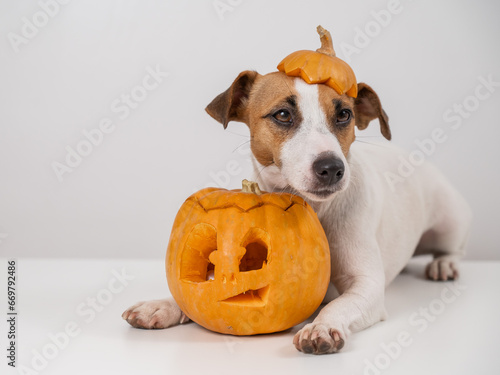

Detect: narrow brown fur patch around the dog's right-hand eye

[318,84,356,157]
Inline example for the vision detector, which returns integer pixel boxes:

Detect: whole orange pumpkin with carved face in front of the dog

[166,180,330,335]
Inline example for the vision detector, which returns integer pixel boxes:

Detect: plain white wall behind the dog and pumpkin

[0,0,500,259]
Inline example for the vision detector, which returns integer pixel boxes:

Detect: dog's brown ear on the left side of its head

[205,70,259,129]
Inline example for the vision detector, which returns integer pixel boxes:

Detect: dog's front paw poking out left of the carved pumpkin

[122,299,189,329]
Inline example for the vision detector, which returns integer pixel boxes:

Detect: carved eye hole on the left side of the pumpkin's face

[180,223,217,283]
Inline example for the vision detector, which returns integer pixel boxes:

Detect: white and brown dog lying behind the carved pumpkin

[122,71,472,354]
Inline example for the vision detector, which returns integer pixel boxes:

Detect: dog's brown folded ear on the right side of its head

[354,83,391,140]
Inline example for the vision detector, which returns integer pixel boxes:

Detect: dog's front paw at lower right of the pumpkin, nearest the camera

[293,323,344,354]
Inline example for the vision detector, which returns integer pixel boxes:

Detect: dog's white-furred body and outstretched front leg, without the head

[294,143,471,353]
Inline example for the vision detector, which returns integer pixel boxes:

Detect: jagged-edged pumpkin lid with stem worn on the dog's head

[278,26,358,98]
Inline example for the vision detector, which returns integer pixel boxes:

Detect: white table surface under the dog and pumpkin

[0,259,500,375]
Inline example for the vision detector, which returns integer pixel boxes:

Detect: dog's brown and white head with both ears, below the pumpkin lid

[206,71,391,201]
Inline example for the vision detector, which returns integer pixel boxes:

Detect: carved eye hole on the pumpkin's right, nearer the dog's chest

[240,228,270,272]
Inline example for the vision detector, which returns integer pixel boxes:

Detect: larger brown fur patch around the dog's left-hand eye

[247,72,302,167]
